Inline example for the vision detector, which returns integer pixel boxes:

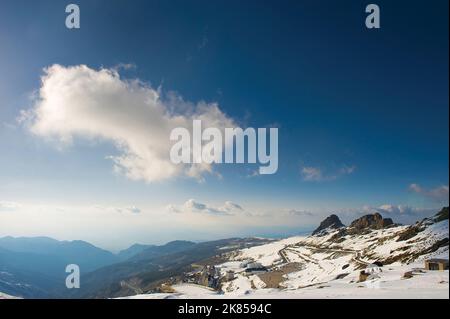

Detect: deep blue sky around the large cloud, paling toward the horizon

[0,1,449,247]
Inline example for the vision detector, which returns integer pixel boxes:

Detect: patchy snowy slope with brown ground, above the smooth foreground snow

[222,212,449,296]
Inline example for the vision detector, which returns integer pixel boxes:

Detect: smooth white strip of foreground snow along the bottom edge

[121,265,449,299]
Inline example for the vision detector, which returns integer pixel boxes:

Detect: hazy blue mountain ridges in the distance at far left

[0,236,207,298]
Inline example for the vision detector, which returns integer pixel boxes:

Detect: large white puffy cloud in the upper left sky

[21,65,234,182]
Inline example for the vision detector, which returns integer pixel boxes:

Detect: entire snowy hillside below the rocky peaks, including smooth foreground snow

[121,213,449,298]
